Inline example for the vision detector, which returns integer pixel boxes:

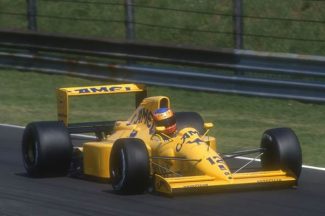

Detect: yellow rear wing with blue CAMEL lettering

[57,84,147,126]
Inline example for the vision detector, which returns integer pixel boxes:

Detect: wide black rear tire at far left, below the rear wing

[22,122,73,177]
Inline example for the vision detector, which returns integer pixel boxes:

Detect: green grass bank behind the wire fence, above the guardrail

[0,0,325,55]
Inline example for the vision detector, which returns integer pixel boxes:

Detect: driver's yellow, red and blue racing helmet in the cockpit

[153,108,176,135]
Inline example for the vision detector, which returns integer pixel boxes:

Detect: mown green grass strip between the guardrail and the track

[0,70,325,166]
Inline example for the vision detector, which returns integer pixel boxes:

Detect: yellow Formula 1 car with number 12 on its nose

[22,84,302,195]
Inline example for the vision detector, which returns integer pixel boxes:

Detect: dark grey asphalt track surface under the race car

[0,126,325,216]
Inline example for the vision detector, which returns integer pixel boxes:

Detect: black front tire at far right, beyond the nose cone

[261,128,302,179]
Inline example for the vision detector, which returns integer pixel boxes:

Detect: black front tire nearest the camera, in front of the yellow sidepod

[110,138,150,194]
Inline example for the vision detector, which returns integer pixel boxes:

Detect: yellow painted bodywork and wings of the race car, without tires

[57,84,296,194]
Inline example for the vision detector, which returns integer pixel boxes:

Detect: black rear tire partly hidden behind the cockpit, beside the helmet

[175,112,205,135]
